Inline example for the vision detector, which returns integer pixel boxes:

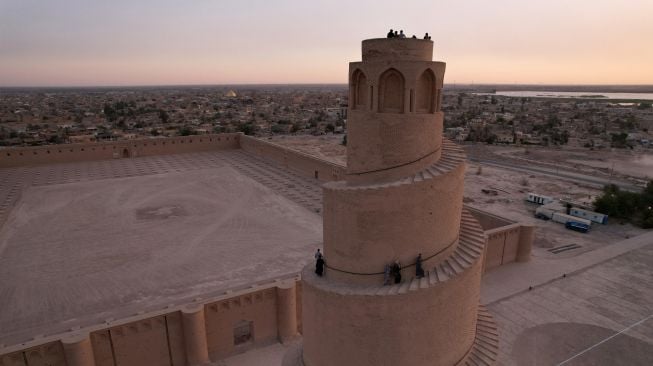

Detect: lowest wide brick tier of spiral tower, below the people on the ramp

[302,212,485,366]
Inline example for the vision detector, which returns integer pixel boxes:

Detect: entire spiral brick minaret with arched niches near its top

[284,38,498,366]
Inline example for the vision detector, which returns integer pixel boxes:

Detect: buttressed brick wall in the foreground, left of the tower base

[0,277,301,366]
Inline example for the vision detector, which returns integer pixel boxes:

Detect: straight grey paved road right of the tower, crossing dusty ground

[469,157,642,192]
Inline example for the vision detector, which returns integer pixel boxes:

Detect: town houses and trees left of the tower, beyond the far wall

[0,86,347,146]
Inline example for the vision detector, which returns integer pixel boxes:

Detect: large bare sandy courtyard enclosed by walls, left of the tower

[0,152,322,344]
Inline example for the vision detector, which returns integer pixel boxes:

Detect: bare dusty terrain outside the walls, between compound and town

[269,135,653,258]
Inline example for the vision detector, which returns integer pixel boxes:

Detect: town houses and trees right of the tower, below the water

[443,93,653,149]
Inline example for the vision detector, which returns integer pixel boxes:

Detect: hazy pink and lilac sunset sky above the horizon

[0,0,653,86]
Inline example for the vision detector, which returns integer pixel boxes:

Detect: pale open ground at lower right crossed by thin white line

[482,240,653,366]
